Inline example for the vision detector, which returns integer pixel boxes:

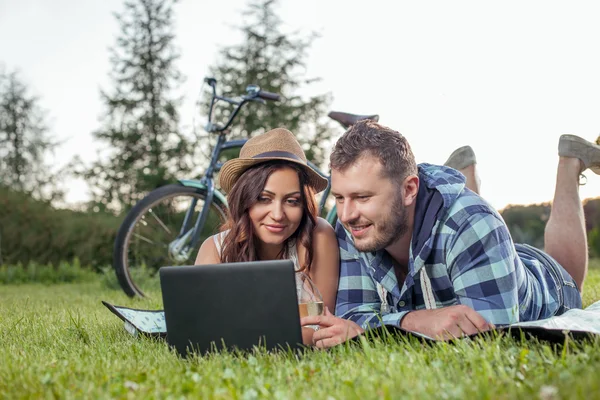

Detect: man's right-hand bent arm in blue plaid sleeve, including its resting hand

[360,207,510,339]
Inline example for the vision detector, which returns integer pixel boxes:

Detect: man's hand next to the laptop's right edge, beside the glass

[300,307,364,349]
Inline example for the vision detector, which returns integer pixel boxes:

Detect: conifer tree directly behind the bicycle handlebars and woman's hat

[204,0,333,164]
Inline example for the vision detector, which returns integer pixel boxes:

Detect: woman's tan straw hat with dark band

[219,128,328,193]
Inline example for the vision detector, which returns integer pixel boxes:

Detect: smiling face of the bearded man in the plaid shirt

[331,156,408,252]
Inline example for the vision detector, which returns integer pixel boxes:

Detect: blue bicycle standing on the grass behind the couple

[113,78,379,297]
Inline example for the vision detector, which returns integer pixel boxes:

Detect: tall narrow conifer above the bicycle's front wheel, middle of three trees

[84,0,190,211]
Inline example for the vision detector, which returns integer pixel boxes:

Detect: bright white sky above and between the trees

[0,0,600,208]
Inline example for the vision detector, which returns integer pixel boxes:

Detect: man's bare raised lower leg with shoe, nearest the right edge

[544,135,600,292]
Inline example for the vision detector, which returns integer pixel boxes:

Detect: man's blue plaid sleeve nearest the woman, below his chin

[335,222,407,329]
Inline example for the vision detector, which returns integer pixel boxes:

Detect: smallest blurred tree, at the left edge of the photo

[0,67,63,201]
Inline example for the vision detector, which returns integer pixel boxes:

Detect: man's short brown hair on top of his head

[329,120,417,183]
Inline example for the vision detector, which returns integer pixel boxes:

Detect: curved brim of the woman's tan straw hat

[219,157,329,193]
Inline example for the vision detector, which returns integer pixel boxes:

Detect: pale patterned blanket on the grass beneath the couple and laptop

[102,301,600,342]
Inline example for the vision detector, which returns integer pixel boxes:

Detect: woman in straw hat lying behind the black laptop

[195,128,339,344]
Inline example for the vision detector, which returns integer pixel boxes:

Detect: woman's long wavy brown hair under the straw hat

[221,161,317,271]
